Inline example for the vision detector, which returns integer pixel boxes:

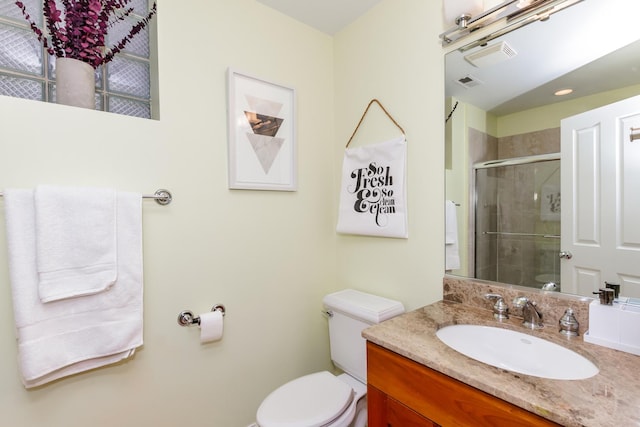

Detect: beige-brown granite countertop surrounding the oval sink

[362,301,640,427]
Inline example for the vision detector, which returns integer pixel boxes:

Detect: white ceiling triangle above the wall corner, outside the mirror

[257,0,381,35]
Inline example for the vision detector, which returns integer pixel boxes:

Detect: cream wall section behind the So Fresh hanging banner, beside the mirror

[334,0,444,308]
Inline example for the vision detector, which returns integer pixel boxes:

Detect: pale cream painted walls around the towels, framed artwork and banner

[0,0,444,427]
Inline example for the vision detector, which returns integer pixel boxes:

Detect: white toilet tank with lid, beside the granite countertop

[323,289,404,384]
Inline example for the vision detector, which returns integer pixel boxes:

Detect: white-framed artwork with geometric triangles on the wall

[227,68,297,191]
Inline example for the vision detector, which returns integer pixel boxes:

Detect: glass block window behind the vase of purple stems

[0,0,157,119]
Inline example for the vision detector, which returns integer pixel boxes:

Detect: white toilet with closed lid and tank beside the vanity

[257,289,404,427]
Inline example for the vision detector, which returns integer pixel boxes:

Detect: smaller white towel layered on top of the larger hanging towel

[35,186,117,302]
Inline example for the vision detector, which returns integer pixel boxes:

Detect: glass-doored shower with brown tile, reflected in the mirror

[474,154,561,291]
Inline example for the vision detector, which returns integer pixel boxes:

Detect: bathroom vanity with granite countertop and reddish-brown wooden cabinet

[363,280,640,427]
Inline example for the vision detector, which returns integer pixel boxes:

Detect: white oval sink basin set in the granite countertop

[436,325,599,380]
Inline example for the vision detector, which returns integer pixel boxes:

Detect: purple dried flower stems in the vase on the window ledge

[15,0,157,68]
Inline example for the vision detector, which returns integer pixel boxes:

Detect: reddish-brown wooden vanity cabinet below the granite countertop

[367,342,559,427]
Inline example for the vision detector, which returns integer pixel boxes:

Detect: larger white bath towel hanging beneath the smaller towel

[4,189,143,388]
